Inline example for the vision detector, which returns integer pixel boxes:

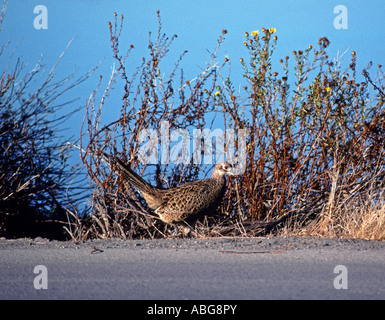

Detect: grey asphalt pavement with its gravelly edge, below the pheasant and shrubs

[0,237,385,300]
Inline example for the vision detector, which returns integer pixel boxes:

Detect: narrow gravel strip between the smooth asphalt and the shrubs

[0,236,385,251]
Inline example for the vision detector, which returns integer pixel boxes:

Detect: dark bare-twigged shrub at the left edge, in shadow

[0,40,89,239]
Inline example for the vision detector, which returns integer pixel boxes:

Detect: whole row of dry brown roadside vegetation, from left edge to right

[0,6,385,240]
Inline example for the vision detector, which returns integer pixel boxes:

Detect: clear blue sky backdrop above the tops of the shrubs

[0,0,385,190]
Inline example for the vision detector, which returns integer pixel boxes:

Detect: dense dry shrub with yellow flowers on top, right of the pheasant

[217,28,385,240]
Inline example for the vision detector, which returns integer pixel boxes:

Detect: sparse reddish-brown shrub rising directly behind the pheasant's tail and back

[74,13,230,238]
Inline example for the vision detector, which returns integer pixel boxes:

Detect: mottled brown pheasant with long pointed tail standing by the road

[104,154,234,234]
